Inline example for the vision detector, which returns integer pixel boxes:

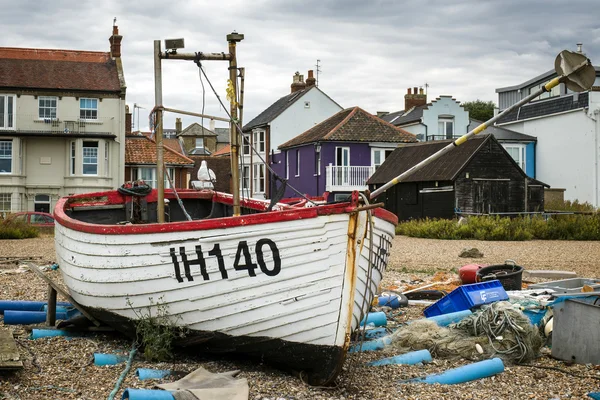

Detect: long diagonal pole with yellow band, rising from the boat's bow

[370,76,564,200]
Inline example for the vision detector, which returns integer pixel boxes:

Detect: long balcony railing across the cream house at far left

[0,114,116,134]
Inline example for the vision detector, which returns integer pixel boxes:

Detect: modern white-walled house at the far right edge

[496,47,600,207]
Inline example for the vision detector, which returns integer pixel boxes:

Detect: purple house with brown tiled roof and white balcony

[272,107,417,200]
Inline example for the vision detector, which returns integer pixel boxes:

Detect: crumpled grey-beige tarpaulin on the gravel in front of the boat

[157,367,250,400]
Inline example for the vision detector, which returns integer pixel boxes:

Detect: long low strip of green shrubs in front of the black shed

[396,213,600,241]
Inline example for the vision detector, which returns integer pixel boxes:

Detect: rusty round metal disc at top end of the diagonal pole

[554,50,596,92]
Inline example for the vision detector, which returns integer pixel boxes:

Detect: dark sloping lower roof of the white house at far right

[496,92,589,124]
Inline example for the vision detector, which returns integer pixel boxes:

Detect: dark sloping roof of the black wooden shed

[367,134,494,185]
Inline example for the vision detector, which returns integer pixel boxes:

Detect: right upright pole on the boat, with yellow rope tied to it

[227,33,244,216]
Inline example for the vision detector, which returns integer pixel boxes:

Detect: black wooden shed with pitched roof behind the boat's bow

[368,134,547,220]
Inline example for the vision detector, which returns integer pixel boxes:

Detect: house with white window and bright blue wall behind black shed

[467,119,537,178]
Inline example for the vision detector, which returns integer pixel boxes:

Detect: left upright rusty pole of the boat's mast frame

[154,40,165,223]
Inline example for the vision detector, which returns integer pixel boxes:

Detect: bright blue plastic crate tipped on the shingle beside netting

[423,280,508,317]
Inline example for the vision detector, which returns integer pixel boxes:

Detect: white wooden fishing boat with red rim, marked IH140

[54,186,397,384]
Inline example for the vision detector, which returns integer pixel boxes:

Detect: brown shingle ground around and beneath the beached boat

[0,237,600,400]
